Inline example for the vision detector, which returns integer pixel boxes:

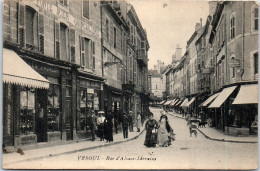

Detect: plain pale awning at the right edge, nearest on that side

[232,84,258,104]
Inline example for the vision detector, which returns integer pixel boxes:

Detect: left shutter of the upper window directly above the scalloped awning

[18,4,26,47]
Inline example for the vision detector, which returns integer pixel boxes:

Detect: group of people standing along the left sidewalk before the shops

[86,110,142,142]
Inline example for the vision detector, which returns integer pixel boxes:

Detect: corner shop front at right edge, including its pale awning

[226,84,258,135]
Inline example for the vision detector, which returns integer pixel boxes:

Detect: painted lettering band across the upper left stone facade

[33,0,101,38]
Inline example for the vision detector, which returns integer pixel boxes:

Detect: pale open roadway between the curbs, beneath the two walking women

[2,108,258,170]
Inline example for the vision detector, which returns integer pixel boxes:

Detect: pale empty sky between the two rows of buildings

[128,0,209,69]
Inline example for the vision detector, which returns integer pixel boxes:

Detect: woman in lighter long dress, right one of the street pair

[157,115,170,147]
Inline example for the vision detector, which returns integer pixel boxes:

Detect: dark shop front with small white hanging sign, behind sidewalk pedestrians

[76,76,103,139]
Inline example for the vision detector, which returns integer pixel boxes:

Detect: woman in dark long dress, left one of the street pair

[144,113,158,147]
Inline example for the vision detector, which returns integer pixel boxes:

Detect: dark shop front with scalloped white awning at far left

[3,46,80,147]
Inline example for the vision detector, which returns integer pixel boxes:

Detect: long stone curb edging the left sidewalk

[5,129,145,165]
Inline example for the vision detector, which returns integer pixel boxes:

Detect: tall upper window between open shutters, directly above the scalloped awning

[25,6,38,48]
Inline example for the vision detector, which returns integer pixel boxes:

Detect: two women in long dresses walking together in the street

[144,111,175,147]
